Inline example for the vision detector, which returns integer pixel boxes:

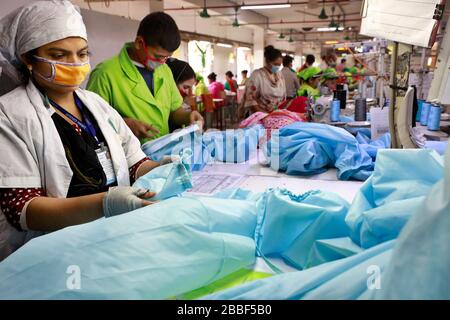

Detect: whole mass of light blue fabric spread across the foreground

[0,142,450,299]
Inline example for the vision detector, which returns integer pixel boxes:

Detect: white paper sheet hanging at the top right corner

[360,0,441,47]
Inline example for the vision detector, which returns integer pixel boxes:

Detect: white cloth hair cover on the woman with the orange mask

[0,0,87,95]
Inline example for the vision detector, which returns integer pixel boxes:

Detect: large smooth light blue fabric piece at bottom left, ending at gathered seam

[0,197,256,299]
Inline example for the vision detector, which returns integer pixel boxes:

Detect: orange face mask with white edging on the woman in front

[33,56,91,87]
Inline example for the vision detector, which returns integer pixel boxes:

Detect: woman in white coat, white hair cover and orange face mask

[0,1,159,260]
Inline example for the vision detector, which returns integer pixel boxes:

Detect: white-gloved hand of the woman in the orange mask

[103,186,156,217]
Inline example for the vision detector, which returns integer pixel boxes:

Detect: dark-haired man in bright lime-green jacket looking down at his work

[87,12,203,142]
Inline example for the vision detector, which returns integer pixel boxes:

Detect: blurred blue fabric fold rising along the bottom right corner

[371,141,450,300]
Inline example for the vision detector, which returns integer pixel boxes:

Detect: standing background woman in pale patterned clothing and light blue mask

[239,46,286,118]
